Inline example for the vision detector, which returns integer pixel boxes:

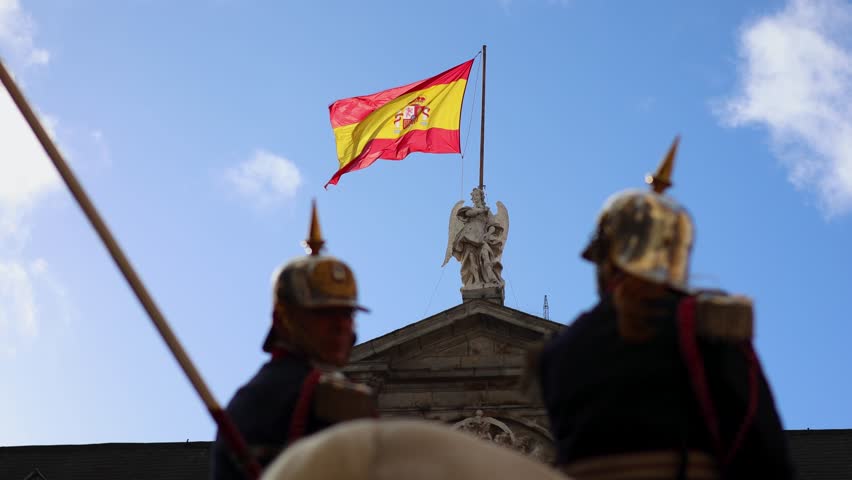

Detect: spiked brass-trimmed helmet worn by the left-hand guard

[263,202,368,351]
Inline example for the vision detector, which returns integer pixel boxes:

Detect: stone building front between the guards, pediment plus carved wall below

[345,299,562,462]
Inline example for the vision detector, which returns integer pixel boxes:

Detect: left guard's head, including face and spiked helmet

[263,201,367,366]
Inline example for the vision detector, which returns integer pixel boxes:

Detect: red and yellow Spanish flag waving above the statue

[325,59,473,187]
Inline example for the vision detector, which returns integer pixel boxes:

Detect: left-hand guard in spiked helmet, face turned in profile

[211,204,375,480]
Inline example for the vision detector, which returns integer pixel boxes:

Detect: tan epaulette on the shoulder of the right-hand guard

[695,293,754,342]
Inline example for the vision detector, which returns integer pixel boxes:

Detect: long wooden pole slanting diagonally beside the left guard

[0,61,261,479]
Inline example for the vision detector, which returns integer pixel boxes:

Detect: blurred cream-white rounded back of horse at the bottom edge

[262,419,568,480]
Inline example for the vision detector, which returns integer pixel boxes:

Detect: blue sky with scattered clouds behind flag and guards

[0,0,852,445]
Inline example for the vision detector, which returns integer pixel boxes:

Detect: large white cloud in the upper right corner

[717,0,852,216]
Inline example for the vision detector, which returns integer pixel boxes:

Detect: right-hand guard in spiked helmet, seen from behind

[534,138,793,480]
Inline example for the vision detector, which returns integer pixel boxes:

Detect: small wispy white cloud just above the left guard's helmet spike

[225,150,302,206]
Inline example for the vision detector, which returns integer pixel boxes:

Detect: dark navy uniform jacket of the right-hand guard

[539,296,793,479]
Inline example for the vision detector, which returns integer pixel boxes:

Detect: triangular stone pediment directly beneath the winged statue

[350,300,562,368]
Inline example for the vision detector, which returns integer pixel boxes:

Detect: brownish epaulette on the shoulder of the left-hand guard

[314,372,376,423]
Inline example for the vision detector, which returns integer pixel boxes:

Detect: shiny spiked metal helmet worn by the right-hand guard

[582,137,694,291]
